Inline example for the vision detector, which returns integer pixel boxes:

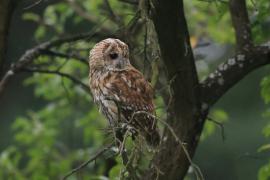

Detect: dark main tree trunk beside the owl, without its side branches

[145,0,203,179]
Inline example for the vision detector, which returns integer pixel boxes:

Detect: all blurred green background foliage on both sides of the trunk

[0,0,270,180]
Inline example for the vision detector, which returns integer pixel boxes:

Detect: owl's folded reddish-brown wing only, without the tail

[103,68,154,120]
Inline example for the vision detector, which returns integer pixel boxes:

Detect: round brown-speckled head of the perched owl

[89,38,130,71]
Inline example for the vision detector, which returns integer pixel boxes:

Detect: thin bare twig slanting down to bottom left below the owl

[62,143,113,180]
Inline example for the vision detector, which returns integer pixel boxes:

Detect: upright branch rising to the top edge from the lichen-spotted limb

[229,0,252,51]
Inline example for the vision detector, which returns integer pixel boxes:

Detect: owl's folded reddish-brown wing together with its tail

[98,68,160,145]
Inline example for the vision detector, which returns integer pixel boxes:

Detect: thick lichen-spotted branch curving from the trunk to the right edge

[201,46,270,107]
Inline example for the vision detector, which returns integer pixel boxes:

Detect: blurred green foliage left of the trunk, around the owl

[0,0,150,180]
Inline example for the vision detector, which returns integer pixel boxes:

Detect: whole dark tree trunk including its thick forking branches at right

[144,0,270,180]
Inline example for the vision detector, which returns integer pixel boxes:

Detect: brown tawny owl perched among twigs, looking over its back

[89,38,160,146]
